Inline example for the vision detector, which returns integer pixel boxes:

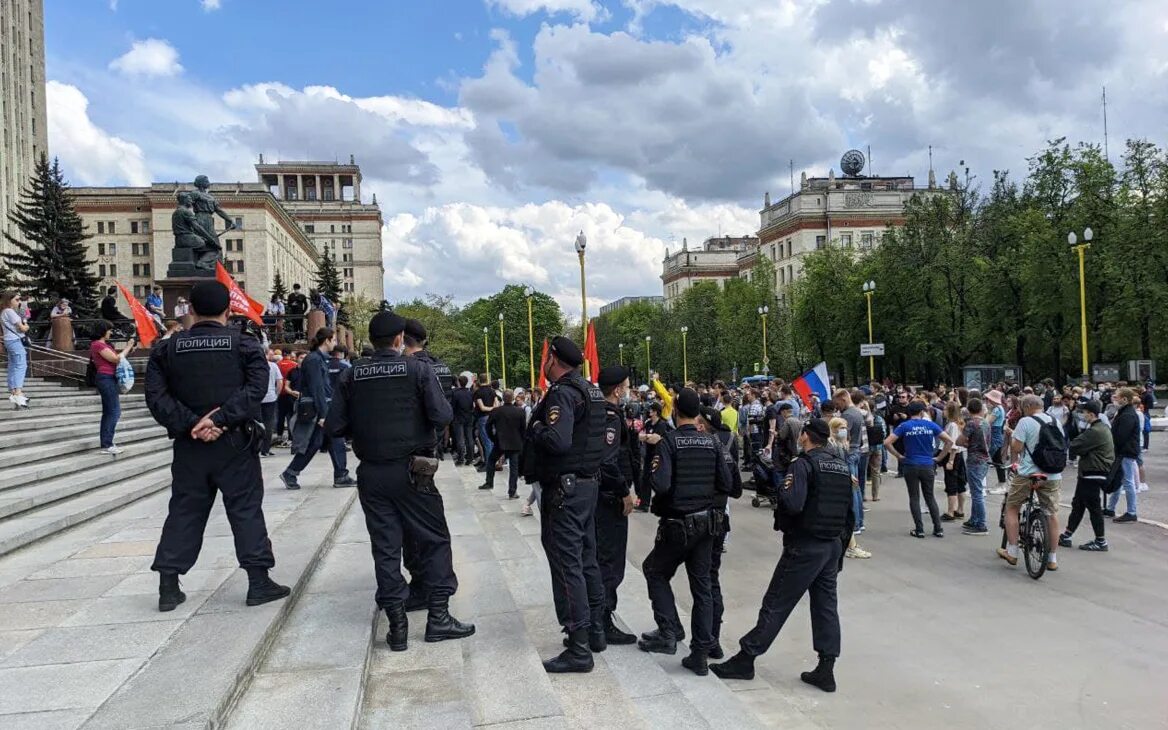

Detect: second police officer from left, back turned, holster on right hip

[325,312,474,652]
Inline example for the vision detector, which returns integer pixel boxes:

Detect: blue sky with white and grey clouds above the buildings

[46,0,1168,314]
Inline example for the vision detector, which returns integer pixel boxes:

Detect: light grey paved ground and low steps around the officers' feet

[0,429,1168,730]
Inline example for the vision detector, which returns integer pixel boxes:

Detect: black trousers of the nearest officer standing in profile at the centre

[540,479,604,633]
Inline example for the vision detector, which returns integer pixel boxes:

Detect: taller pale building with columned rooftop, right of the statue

[256,155,385,301]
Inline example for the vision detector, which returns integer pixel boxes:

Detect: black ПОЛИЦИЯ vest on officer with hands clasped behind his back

[166,322,247,419]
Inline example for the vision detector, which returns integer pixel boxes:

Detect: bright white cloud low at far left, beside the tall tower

[44,81,151,186]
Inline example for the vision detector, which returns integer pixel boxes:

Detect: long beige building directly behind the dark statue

[70,182,319,301]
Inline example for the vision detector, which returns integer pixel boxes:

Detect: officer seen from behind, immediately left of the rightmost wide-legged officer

[637,388,730,676]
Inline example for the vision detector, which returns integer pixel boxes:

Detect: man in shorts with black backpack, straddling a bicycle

[997,395,1063,570]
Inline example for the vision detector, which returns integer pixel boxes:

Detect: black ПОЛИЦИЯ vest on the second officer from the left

[345,354,433,464]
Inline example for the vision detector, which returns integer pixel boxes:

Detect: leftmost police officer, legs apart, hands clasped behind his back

[146,281,290,611]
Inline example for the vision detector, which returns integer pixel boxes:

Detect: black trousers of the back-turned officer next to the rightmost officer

[641,520,714,651]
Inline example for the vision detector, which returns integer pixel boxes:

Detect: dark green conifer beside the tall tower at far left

[4,154,99,318]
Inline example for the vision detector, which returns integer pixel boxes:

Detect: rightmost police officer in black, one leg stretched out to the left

[710,418,855,691]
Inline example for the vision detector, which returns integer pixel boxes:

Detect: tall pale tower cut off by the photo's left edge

[0,0,49,255]
